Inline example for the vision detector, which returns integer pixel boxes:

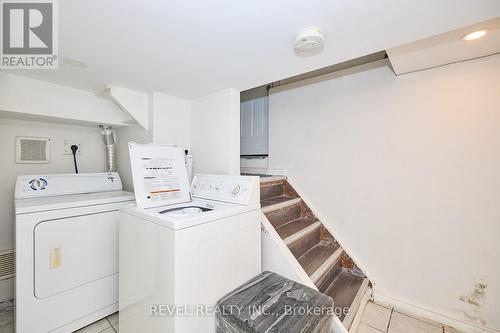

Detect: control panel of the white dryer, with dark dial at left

[15,172,122,199]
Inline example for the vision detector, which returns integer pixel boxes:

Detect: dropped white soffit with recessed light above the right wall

[387,17,500,74]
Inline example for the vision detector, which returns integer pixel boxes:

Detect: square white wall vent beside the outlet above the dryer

[16,136,50,164]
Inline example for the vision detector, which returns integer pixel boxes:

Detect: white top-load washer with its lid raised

[120,144,261,333]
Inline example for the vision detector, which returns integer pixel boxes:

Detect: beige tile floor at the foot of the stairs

[356,302,456,333]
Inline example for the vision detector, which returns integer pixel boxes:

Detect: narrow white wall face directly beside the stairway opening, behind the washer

[191,89,240,175]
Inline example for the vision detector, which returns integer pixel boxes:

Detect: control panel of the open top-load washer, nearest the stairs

[191,174,260,205]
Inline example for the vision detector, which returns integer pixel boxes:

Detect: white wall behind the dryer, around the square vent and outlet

[0,118,106,300]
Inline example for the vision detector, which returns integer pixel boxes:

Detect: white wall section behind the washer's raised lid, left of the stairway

[117,89,240,191]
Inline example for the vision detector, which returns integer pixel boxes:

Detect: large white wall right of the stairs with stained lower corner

[269,55,500,330]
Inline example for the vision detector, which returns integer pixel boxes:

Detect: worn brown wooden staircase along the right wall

[260,177,369,330]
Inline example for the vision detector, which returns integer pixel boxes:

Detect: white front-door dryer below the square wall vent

[15,173,134,333]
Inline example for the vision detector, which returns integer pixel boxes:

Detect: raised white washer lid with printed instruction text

[128,142,191,207]
